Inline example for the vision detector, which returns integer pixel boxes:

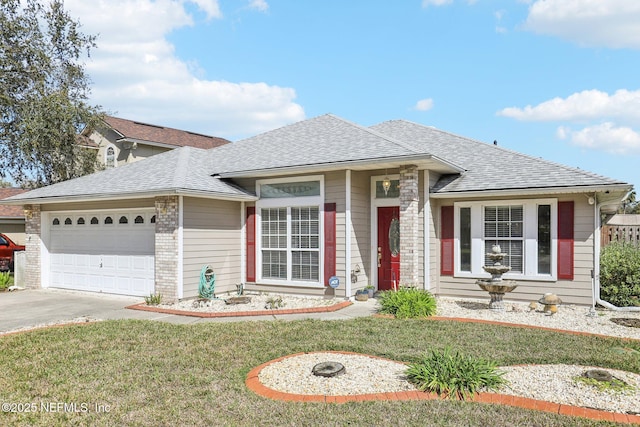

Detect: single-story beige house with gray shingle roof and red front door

[3,115,631,304]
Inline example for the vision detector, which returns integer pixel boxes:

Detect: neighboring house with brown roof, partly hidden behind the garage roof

[79,116,230,168]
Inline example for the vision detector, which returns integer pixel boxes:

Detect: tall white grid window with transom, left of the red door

[256,177,323,284]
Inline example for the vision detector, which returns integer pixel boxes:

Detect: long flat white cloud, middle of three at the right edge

[497,89,640,123]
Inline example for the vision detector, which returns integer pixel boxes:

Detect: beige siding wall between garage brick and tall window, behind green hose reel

[183,197,244,298]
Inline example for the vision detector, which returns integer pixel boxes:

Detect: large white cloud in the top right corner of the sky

[524,0,640,49]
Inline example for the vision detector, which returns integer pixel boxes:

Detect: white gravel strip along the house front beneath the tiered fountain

[436,296,640,339]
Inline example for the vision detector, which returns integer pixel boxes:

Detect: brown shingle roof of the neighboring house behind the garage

[103,116,231,149]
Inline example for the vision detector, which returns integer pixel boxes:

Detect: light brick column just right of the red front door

[400,165,420,286]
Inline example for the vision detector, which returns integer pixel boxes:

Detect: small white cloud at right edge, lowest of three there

[556,122,640,155]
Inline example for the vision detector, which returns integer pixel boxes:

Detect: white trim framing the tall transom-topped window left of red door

[256,175,325,288]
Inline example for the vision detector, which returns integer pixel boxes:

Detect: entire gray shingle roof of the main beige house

[2,114,628,201]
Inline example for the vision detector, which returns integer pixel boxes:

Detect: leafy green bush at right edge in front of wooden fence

[600,243,640,307]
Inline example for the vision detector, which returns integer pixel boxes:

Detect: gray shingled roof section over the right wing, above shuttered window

[372,120,625,193]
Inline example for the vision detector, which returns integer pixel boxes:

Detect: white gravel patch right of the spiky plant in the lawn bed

[498,365,640,413]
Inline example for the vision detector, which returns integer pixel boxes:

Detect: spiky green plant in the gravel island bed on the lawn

[406,347,505,399]
